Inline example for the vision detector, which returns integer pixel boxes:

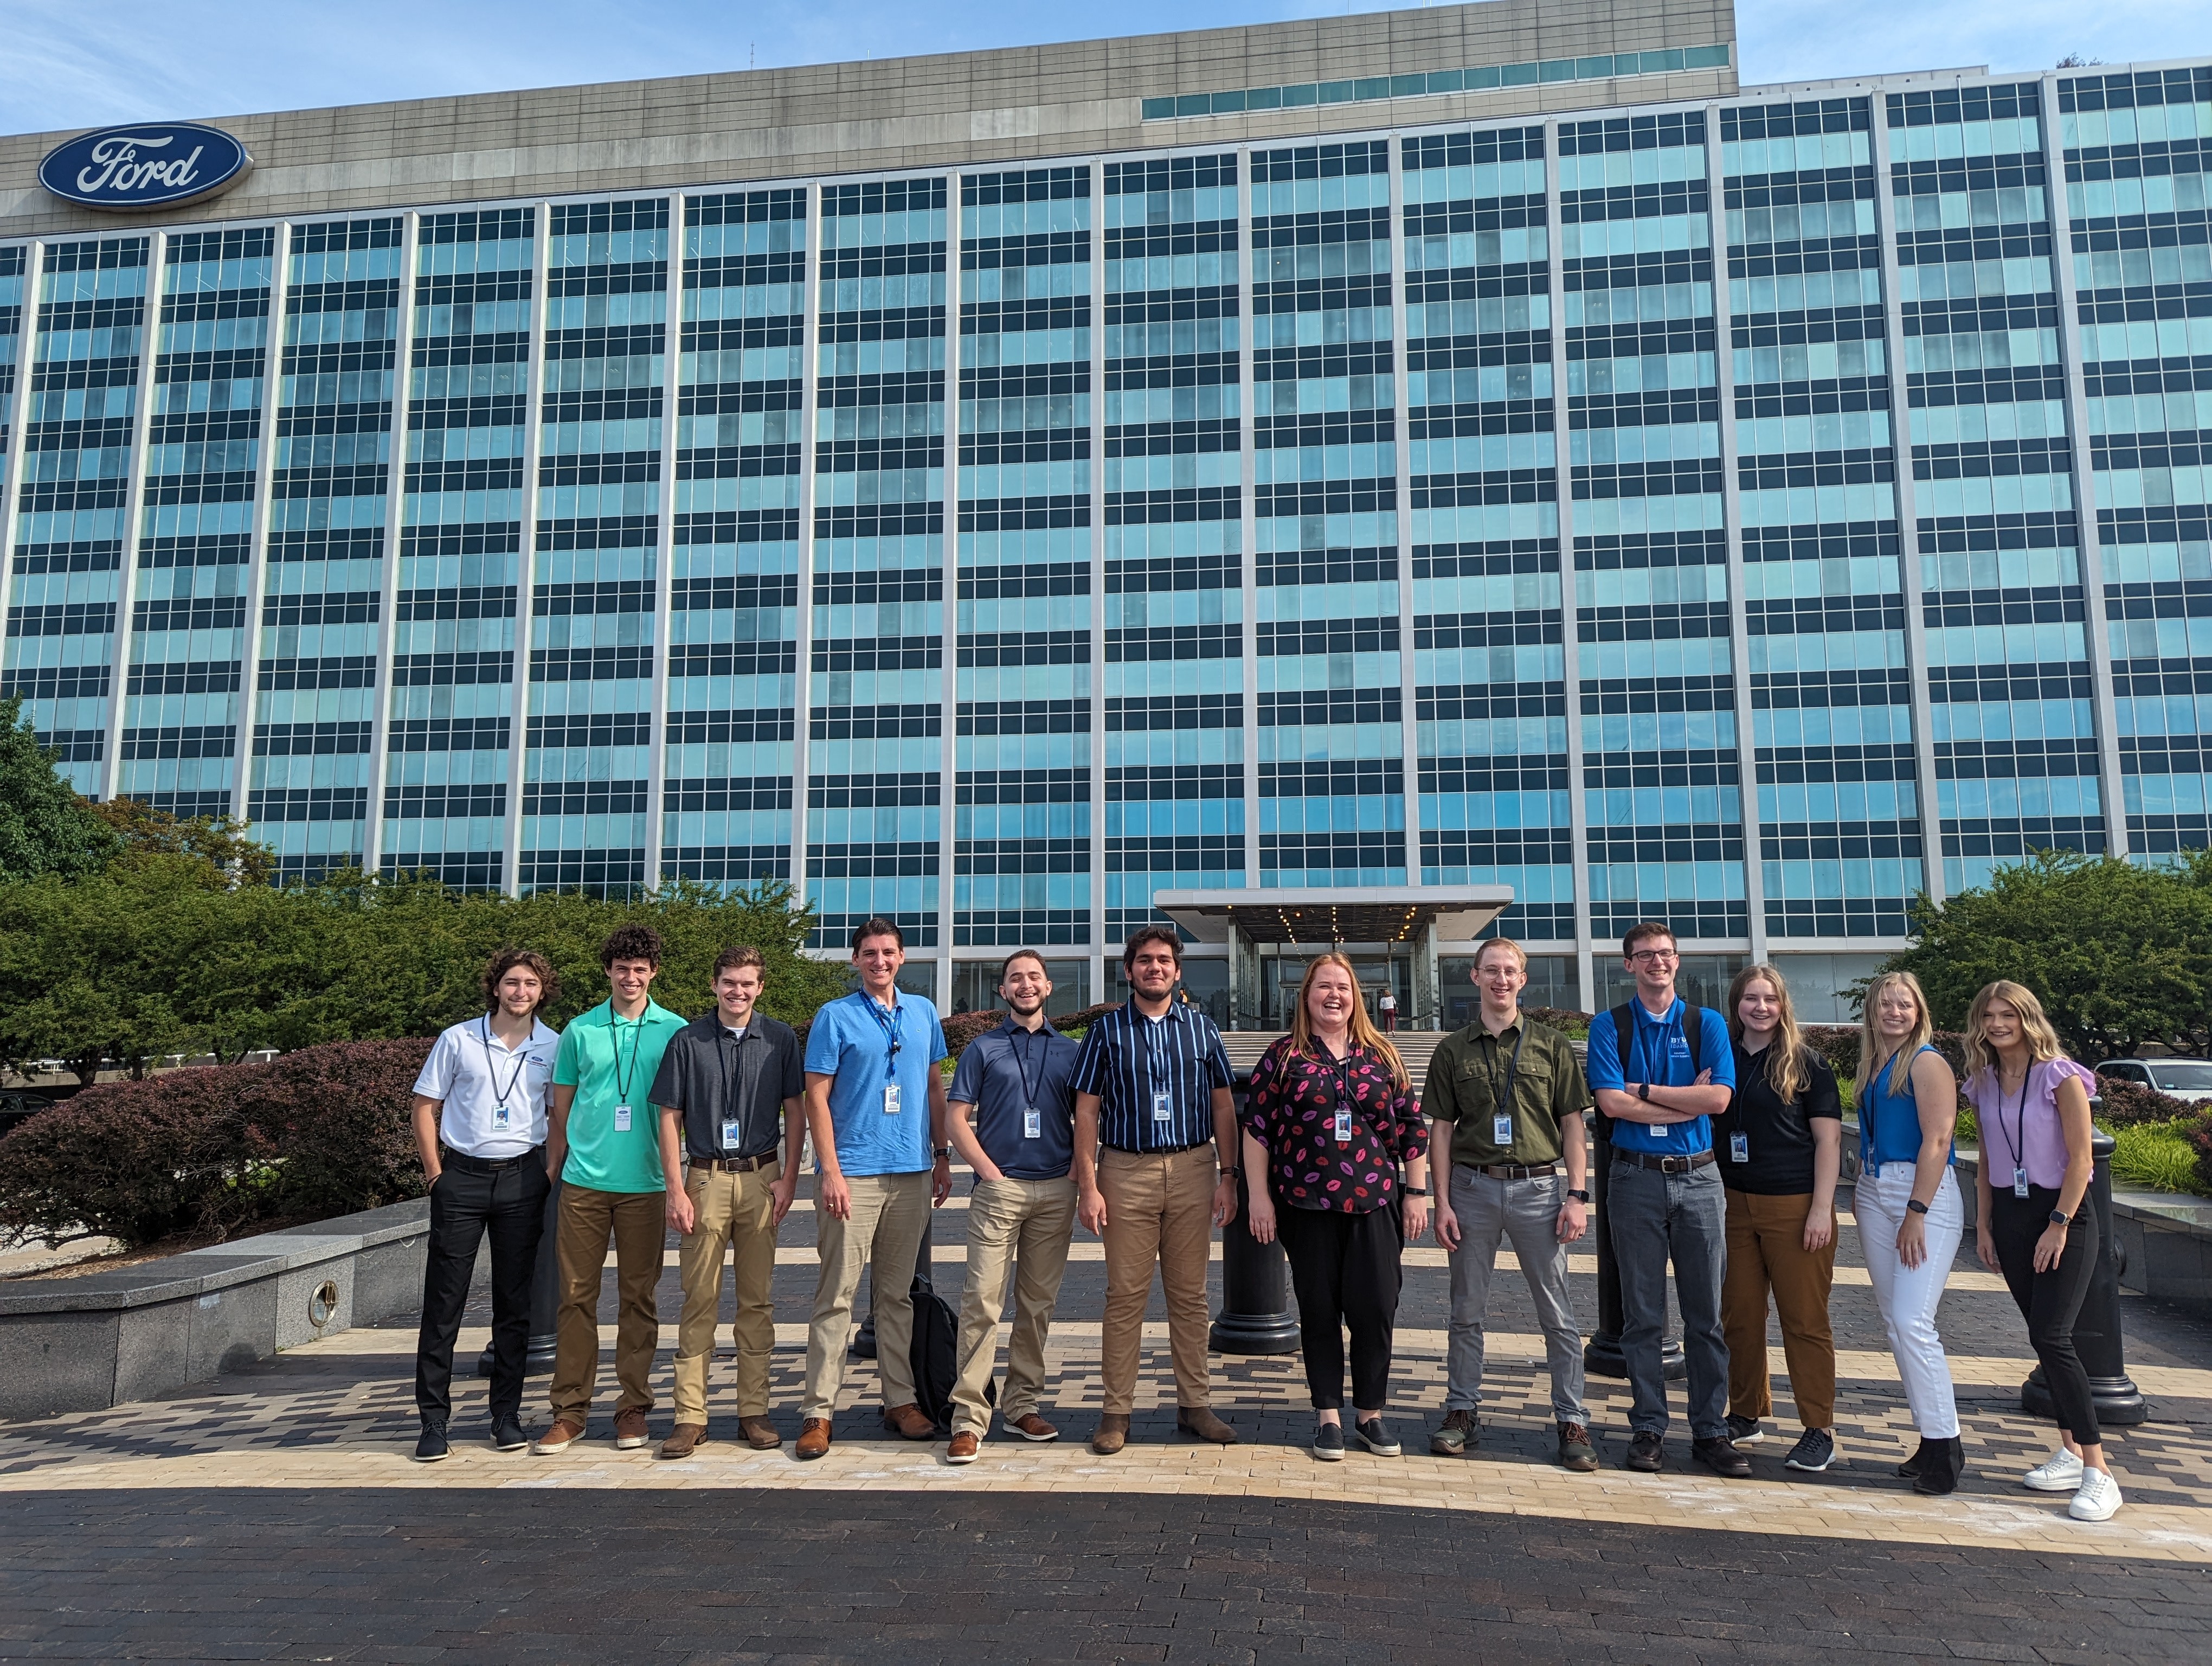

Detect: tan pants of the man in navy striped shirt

[1099,1146,1214,1416]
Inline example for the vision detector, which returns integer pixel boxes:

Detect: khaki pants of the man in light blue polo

[799,1170,929,1418]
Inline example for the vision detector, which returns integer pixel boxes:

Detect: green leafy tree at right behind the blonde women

[1889,850,2212,1064]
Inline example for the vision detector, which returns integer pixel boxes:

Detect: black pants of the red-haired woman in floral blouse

[1274,1203,1405,1412]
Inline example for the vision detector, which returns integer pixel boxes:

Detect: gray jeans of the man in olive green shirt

[1444,1164,1591,1422]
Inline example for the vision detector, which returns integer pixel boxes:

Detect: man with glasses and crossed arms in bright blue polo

[1588,920,1752,1478]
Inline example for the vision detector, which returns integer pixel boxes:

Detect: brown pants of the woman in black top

[1721,1190,1836,1429]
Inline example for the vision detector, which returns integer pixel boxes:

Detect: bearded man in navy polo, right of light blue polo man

[944,949,1082,1463]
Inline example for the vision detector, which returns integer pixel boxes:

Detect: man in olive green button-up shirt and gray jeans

[1420,938,1597,1471]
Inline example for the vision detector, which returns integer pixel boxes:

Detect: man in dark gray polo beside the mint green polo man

[653,945,807,1458]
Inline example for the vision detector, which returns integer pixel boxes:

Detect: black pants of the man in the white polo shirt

[416,1148,553,1422]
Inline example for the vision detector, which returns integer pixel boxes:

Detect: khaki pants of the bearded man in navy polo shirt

[953,1175,1075,1434]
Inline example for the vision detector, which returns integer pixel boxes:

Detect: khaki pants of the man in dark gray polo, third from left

[674,1162,781,1425]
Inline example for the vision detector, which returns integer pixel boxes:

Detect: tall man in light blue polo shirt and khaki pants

[799,918,953,1458]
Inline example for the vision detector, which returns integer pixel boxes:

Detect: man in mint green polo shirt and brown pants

[531,925,684,1453]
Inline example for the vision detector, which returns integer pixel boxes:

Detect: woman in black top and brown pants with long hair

[1712,965,1843,1471]
